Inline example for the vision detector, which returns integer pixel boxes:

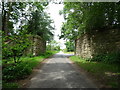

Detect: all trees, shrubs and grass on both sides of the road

[0,1,120,87]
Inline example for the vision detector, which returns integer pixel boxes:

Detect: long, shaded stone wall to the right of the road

[75,29,120,58]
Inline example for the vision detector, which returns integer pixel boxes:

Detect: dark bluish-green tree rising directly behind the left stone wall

[28,10,54,40]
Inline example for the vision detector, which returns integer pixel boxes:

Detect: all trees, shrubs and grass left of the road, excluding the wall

[0,1,55,88]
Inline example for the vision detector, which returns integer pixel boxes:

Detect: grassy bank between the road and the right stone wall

[70,56,120,88]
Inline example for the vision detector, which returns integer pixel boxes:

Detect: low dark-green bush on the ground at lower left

[2,62,32,81]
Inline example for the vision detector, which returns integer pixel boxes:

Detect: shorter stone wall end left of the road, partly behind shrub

[25,35,46,56]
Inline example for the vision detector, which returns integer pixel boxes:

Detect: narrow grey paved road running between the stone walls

[28,53,96,88]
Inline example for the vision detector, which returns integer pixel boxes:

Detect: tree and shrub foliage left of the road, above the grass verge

[2,2,54,63]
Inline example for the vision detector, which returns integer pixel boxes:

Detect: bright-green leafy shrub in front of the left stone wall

[2,33,30,63]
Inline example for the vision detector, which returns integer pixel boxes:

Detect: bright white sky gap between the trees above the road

[47,3,65,49]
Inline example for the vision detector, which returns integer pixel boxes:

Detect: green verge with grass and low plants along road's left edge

[2,51,57,88]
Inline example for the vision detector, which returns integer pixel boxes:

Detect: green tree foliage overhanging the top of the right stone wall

[60,2,120,40]
